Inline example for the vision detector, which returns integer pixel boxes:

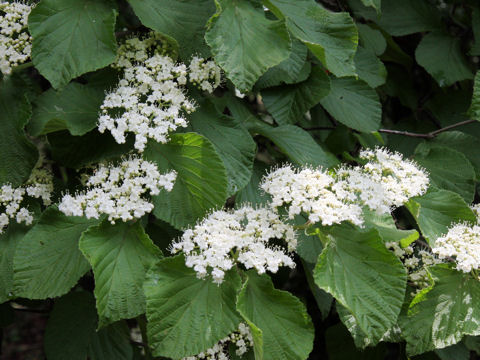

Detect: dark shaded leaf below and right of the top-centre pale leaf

[262,67,330,125]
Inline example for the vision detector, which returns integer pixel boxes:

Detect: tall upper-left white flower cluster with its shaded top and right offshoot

[98,33,220,152]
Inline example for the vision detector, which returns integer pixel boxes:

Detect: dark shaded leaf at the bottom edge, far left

[44,291,97,360]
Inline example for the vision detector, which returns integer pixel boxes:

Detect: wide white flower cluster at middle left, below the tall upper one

[58,157,176,223]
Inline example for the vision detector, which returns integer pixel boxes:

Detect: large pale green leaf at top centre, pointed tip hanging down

[205,0,291,92]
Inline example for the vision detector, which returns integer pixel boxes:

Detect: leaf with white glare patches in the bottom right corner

[400,264,480,355]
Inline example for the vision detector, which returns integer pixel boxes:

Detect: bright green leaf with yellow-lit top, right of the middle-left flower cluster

[144,133,227,228]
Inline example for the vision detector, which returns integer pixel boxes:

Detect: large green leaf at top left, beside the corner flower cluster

[28,0,117,88]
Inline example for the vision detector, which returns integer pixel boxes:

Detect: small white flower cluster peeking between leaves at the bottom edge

[182,323,253,360]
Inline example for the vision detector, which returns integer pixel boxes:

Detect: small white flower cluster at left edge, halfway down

[0,168,53,234]
